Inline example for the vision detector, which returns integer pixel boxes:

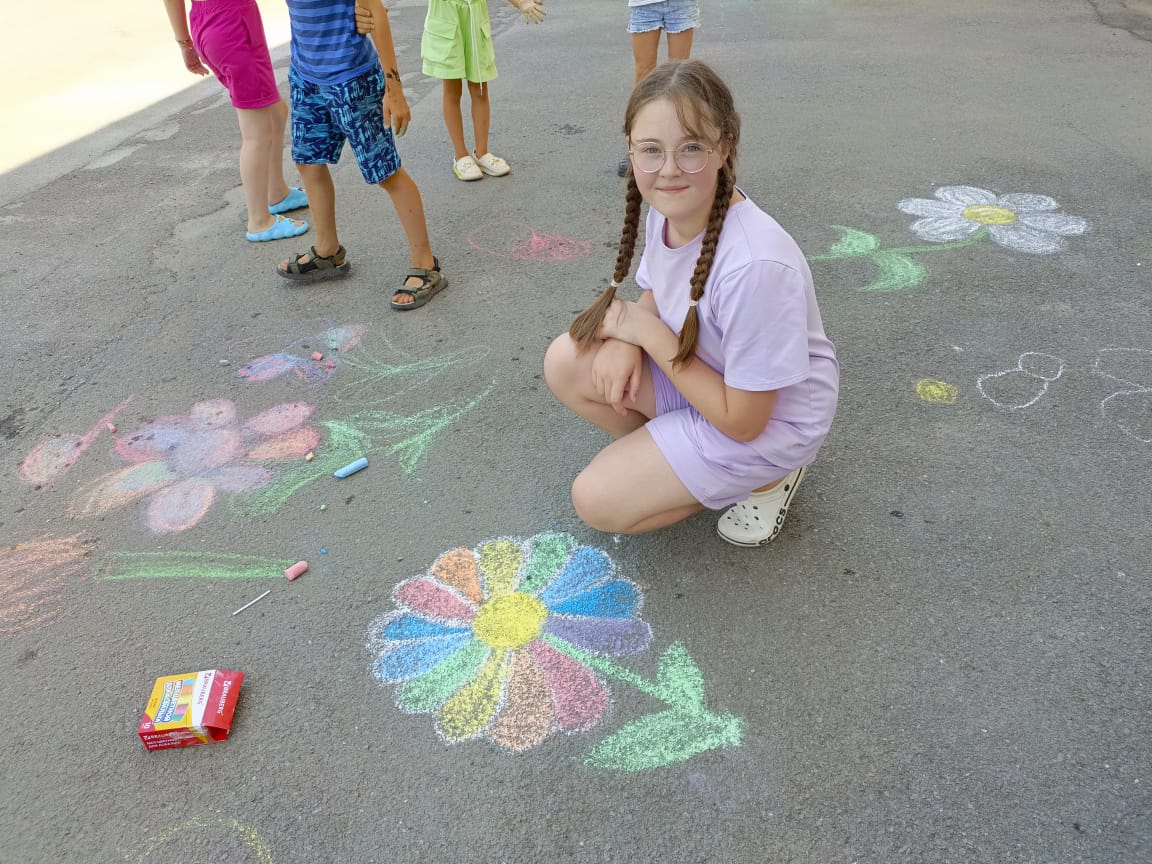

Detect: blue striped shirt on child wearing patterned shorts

[288,0,380,84]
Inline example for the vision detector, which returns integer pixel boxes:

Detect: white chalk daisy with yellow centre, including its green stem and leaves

[809,185,1089,291]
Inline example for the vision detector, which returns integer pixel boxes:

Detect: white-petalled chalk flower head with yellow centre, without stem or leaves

[896,185,1089,255]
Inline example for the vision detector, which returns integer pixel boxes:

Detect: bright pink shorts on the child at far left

[188,0,280,108]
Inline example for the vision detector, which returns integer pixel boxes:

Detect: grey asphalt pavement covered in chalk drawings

[0,0,1152,864]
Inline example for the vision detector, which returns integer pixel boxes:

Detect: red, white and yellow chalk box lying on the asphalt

[137,669,244,750]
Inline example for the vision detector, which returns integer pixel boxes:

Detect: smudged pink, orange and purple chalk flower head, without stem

[75,399,320,535]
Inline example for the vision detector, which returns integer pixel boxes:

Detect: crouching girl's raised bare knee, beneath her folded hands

[544,333,655,438]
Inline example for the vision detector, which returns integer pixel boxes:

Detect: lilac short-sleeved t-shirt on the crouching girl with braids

[636,197,840,468]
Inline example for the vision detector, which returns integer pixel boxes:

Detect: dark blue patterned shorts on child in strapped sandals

[288,67,400,183]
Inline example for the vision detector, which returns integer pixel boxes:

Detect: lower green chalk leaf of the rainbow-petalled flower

[584,708,744,772]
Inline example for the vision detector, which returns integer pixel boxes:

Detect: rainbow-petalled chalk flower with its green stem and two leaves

[369,532,743,772]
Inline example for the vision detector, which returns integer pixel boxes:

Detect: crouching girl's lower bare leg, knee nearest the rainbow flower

[573,429,704,535]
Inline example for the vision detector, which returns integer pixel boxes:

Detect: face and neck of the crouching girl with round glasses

[628,99,727,245]
